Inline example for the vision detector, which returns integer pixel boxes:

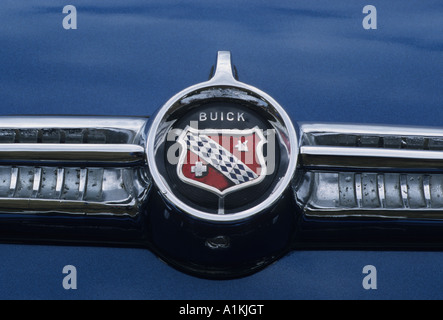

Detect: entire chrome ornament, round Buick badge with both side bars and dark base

[0,51,443,278]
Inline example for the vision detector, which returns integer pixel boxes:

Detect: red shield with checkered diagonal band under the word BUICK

[177,127,267,196]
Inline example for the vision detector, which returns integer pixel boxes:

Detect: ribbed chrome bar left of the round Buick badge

[0,116,150,225]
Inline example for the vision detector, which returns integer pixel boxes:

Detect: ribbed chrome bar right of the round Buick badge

[294,124,443,220]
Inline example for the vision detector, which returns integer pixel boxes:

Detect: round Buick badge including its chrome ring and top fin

[147,52,298,222]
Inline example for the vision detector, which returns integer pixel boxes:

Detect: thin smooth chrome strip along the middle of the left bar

[0,143,145,166]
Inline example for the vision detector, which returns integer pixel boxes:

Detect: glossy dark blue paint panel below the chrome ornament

[0,245,443,300]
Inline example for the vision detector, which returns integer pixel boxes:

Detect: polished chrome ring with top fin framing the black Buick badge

[146,52,298,222]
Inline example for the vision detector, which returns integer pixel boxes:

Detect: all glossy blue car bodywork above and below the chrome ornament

[0,0,443,299]
